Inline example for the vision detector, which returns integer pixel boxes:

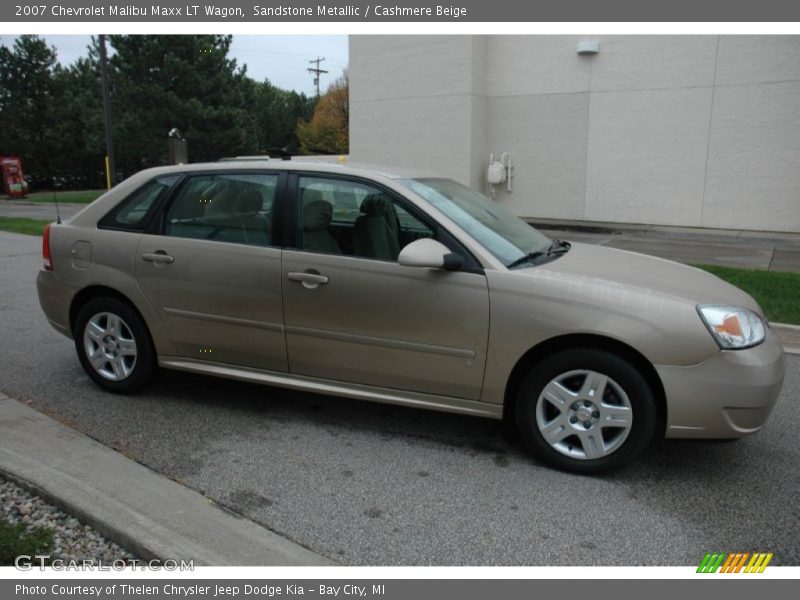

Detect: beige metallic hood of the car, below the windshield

[514,242,763,317]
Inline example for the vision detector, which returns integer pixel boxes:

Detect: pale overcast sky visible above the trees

[0,35,348,96]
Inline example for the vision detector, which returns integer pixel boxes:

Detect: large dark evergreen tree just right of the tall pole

[110,35,255,172]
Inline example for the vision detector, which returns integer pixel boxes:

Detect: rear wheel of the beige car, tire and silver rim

[73,298,157,394]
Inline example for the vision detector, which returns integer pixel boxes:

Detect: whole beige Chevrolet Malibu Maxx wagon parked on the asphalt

[38,160,784,473]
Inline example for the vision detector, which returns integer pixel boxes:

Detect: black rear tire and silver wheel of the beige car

[73,297,158,394]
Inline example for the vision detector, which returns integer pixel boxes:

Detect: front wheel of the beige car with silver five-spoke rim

[515,348,658,475]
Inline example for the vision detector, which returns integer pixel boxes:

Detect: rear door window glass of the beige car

[164,173,278,246]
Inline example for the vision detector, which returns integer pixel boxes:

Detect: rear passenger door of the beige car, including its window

[136,171,288,371]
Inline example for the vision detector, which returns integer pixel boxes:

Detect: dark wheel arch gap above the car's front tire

[503,334,667,436]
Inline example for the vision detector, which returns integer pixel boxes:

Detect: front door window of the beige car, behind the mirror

[298,177,434,261]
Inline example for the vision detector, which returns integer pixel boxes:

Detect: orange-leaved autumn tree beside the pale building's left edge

[297,72,350,154]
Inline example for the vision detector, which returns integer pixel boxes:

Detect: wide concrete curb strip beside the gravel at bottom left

[0,393,336,566]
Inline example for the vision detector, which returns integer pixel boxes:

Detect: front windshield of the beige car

[400,179,552,266]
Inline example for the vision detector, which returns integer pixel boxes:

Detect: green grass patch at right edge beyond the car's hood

[695,265,800,325]
